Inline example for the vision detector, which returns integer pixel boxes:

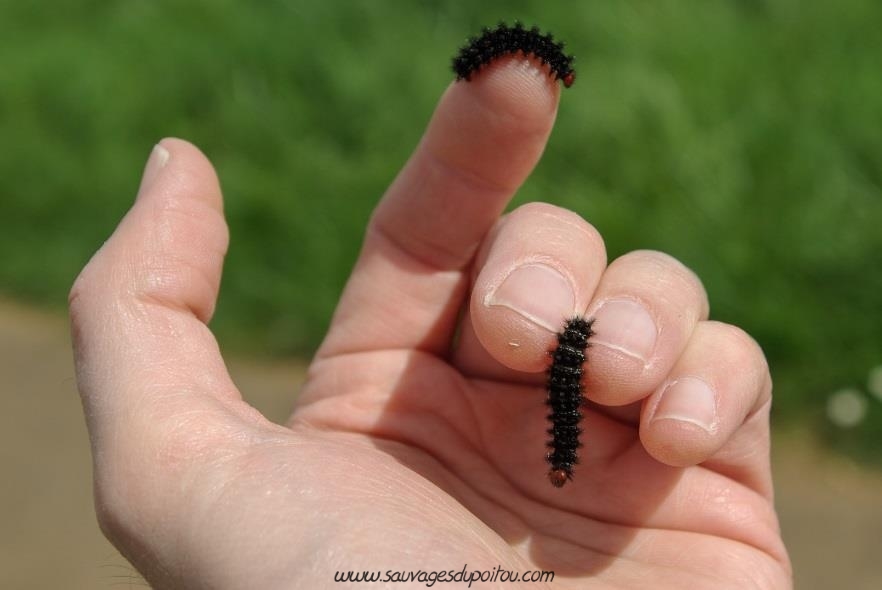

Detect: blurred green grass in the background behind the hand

[0,0,882,461]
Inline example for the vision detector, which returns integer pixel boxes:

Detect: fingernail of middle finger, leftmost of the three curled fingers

[484,263,576,332]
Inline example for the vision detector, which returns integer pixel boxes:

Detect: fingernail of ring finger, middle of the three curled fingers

[592,299,658,364]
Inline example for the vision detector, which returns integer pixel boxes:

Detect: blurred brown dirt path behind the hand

[0,300,882,590]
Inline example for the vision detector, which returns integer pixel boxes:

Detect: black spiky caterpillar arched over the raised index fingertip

[453,22,576,88]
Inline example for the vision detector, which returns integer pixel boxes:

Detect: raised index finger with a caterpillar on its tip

[318,56,560,357]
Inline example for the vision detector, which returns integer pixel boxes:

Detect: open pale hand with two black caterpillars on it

[70,59,791,589]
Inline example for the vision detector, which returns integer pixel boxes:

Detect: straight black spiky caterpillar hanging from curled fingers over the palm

[545,317,594,488]
